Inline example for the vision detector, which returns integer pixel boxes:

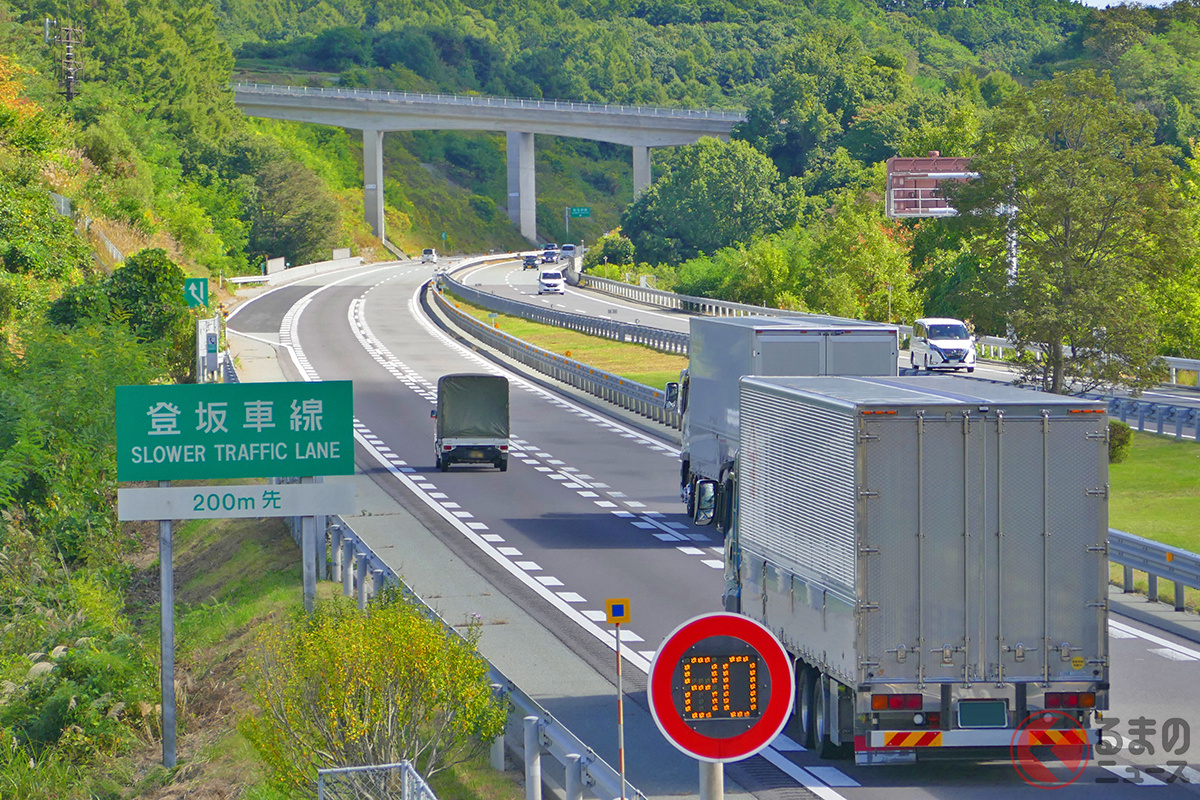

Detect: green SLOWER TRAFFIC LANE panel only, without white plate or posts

[116,380,354,481]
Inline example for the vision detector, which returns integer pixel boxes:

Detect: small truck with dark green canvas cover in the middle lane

[431,373,509,473]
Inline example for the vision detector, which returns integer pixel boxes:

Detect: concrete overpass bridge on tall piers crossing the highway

[233,84,745,241]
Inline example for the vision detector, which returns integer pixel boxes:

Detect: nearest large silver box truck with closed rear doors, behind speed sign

[725,378,1109,764]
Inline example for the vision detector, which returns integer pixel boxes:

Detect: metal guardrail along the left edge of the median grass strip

[432,283,682,428]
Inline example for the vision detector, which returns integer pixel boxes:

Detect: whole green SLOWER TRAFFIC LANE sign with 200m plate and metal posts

[116,380,354,769]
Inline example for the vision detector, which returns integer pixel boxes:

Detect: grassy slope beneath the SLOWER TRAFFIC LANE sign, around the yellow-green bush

[112,519,523,800]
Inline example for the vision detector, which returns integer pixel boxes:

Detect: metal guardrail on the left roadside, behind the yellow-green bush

[317,517,646,800]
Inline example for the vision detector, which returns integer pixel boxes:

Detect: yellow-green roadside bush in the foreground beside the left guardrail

[244,590,506,796]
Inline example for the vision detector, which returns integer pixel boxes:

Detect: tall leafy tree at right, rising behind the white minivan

[949,71,1190,393]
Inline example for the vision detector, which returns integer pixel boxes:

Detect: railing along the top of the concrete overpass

[232,83,746,122]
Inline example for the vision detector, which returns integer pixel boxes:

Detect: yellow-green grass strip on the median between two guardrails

[448,293,688,389]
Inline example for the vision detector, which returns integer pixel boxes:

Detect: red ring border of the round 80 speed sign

[646,612,796,762]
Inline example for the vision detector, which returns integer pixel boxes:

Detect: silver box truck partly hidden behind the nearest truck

[668,317,900,530]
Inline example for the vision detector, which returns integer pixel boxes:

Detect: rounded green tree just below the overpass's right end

[622,138,785,264]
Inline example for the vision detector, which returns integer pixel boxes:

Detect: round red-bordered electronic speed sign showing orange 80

[647,614,796,762]
